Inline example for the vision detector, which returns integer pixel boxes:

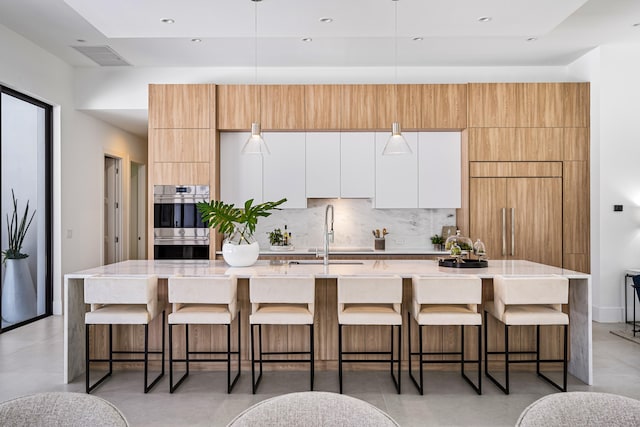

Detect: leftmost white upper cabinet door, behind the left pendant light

[220,132,263,206]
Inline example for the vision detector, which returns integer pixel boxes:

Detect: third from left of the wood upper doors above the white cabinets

[304,85,342,130]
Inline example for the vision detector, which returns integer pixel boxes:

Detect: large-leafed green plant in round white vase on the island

[197,199,287,267]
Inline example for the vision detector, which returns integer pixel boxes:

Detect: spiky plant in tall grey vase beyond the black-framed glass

[2,190,37,323]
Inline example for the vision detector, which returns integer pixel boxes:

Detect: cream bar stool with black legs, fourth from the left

[338,276,402,394]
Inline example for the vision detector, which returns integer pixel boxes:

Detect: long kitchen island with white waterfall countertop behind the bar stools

[64,259,593,384]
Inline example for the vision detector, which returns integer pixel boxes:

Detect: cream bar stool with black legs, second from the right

[407,275,482,394]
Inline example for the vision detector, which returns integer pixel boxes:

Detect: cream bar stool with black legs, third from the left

[249,275,316,394]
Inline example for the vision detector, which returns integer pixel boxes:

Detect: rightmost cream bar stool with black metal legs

[484,275,569,394]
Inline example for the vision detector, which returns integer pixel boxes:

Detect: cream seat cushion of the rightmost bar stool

[485,301,569,325]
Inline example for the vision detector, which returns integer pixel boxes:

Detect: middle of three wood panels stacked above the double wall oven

[149,129,213,162]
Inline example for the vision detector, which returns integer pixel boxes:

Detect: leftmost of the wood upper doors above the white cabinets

[216,85,255,130]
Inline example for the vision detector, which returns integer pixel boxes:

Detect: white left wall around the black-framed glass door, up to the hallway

[0,25,146,314]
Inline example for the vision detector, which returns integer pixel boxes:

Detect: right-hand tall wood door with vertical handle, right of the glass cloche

[507,178,563,267]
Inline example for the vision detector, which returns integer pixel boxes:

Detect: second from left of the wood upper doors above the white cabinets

[260,85,305,130]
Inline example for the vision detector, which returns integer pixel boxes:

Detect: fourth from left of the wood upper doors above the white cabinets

[340,85,378,132]
